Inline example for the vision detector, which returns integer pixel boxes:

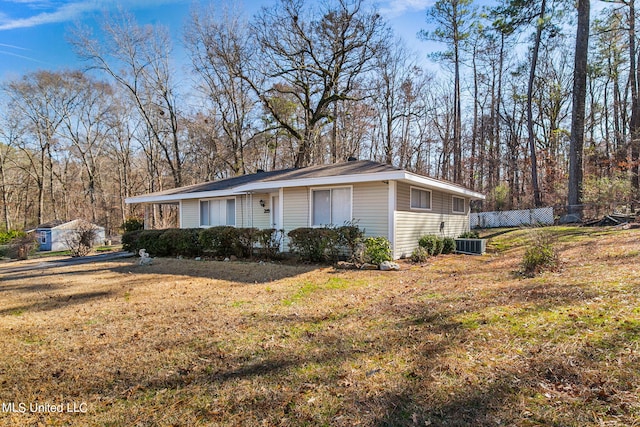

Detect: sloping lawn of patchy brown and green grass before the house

[0,227,640,426]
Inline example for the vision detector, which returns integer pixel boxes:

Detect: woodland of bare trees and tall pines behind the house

[0,0,640,233]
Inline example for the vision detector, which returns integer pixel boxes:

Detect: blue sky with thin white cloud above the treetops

[0,0,433,81]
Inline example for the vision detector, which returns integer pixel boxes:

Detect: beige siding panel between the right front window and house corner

[352,182,390,238]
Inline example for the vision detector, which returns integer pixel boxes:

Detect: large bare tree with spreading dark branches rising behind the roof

[252,0,385,167]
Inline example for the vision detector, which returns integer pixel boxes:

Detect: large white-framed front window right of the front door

[311,187,351,226]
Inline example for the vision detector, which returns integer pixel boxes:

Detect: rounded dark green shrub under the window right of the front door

[287,227,340,262]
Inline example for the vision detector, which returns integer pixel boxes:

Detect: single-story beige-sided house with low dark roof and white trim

[126,160,485,259]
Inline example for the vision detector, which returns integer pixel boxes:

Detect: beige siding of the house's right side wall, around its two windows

[394,183,469,258]
